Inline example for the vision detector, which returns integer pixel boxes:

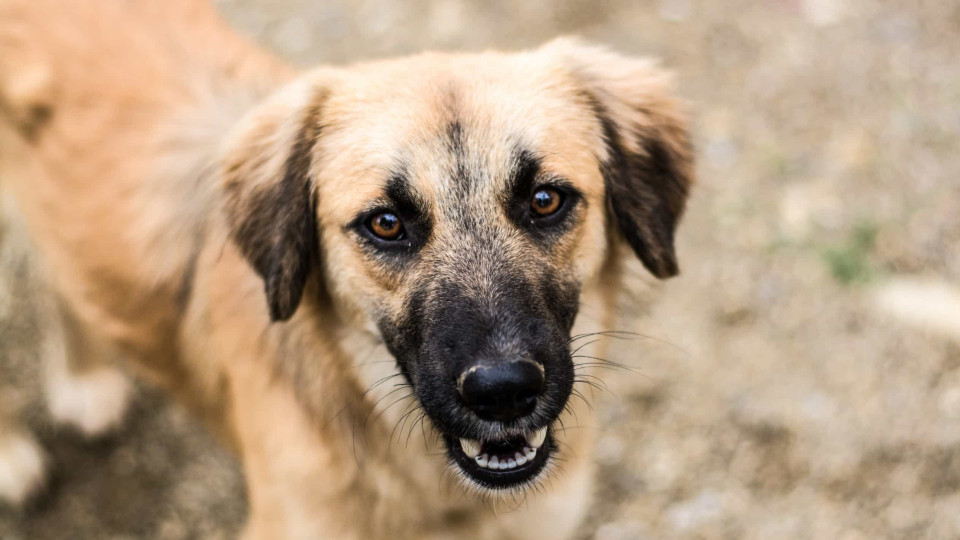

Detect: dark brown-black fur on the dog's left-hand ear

[231,98,320,321]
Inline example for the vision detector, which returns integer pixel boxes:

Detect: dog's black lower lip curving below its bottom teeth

[444,428,554,490]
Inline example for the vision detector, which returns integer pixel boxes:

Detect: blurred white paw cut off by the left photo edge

[0,431,46,506]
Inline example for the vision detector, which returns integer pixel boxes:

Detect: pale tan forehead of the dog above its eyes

[322,54,601,216]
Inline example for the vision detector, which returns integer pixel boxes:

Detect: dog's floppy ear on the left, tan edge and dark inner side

[222,82,326,321]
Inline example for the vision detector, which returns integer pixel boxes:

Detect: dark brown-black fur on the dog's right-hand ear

[587,90,690,279]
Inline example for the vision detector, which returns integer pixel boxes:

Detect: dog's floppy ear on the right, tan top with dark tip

[545,39,694,279]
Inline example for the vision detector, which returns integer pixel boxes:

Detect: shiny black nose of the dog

[457,360,545,422]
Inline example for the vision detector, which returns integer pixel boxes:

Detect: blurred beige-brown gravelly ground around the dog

[0,0,960,540]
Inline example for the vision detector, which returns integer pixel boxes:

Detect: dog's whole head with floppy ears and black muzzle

[224,41,692,489]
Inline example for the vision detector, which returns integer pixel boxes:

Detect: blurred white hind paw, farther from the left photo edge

[47,368,131,437]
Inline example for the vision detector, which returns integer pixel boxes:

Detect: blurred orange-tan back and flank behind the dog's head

[0,0,287,371]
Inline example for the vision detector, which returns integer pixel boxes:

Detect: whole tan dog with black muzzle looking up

[0,0,694,539]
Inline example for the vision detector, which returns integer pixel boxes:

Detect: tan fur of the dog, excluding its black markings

[0,0,689,539]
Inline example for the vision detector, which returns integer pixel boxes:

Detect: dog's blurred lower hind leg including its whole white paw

[43,294,131,437]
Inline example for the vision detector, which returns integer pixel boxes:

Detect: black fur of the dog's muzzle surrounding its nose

[380,255,579,438]
